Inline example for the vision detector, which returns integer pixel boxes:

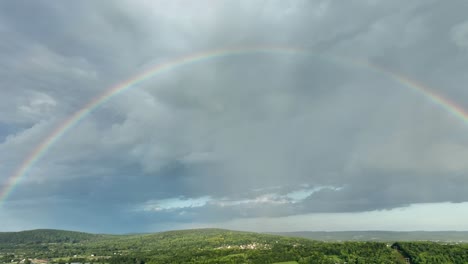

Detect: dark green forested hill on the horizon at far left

[0,229,108,244]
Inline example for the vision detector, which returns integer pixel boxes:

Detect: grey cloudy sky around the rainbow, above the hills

[0,0,468,233]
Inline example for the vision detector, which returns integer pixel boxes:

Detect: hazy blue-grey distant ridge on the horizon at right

[268,231,468,243]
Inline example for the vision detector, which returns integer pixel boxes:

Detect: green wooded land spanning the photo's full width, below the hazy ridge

[0,229,468,264]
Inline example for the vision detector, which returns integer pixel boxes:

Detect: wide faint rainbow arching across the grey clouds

[0,46,468,206]
